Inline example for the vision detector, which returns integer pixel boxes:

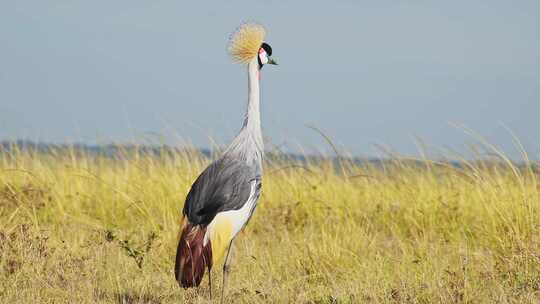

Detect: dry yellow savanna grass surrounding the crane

[0,143,540,303]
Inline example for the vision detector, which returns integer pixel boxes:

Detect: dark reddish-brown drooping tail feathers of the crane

[174,219,212,288]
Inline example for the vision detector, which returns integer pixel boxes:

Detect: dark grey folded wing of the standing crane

[183,158,261,225]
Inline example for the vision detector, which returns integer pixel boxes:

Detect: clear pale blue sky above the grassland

[0,0,540,158]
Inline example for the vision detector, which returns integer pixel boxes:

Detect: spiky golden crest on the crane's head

[229,23,266,64]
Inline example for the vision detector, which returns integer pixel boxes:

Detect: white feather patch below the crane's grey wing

[204,180,259,246]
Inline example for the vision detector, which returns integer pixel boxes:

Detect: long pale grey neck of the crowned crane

[225,57,264,166]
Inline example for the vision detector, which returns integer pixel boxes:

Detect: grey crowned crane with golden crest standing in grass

[174,22,277,301]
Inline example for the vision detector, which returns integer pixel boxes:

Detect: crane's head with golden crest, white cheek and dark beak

[229,23,277,69]
